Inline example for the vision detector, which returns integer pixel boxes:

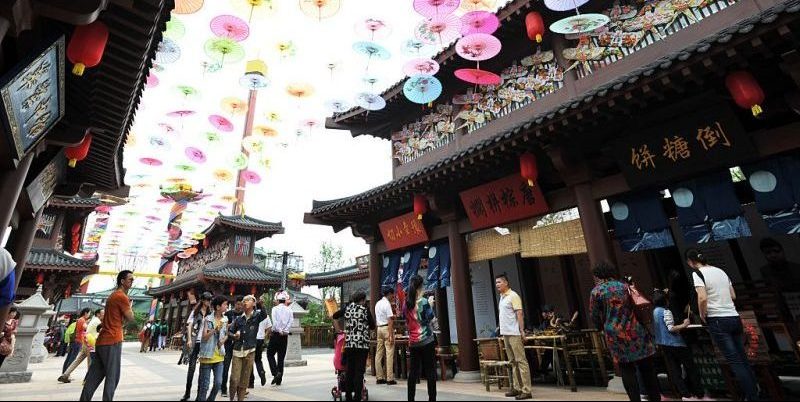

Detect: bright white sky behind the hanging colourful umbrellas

[84,0,506,291]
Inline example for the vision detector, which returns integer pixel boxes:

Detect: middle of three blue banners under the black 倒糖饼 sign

[670,170,752,243]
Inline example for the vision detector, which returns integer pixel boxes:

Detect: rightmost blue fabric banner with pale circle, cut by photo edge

[742,156,800,234]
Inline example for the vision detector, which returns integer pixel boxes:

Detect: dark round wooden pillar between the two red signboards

[445,219,480,382]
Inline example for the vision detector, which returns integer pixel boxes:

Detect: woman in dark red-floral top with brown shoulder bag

[589,262,661,401]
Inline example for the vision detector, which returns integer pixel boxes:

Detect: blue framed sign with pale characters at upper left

[0,36,64,160]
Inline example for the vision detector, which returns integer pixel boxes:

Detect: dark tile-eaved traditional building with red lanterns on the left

[0,0,175,300]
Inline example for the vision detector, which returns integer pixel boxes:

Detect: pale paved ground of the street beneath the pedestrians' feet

[0,344,625,401]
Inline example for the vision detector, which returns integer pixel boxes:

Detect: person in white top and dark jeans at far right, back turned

[686,249,758,401]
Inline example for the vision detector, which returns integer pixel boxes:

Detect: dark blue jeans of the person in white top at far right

[706,317,758,401]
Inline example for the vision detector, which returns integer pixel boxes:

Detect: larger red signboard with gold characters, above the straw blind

[459,174,549,229]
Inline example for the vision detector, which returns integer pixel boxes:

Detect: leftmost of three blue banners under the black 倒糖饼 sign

[609,191,675,252]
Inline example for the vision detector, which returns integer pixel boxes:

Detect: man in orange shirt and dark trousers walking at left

[81,270,133,401]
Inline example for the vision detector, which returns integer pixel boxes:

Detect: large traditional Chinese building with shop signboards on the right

[305,0,800,392]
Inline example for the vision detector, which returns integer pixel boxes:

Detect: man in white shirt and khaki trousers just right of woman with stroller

[375,287,397,385]
